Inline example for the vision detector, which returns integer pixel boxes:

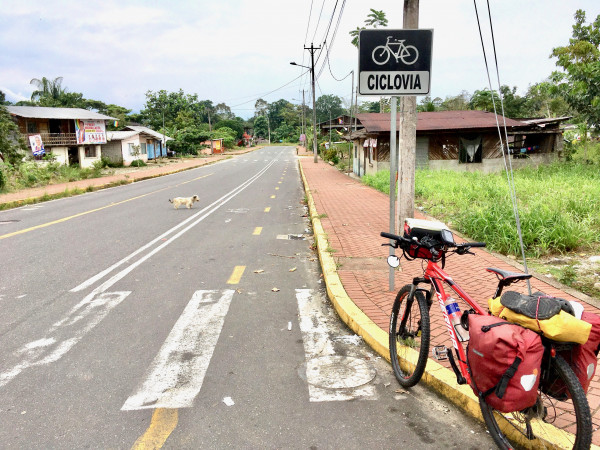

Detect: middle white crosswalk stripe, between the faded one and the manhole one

[121,290,235,411]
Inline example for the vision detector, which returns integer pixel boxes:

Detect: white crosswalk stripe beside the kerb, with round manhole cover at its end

[296,289,377,402]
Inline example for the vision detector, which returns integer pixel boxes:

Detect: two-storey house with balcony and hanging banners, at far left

[6,106,116,167]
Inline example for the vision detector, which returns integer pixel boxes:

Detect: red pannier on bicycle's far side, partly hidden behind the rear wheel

[542,311,600,398]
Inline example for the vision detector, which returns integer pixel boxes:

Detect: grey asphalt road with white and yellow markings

[0,147,493,449]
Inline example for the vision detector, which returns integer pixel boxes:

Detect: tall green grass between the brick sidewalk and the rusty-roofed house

[364,163,600,257]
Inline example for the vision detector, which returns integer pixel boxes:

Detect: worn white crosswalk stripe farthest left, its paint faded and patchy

[0,292,131,387]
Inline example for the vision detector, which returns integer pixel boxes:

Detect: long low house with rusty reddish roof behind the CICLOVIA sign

[342,111,569,176]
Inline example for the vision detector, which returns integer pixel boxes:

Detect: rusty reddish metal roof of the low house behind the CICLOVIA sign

[356,111,525,133]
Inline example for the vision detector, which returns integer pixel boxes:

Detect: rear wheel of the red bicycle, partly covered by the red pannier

[479,355,592,449]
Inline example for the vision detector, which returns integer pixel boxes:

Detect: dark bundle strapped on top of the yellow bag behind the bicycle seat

[500,291,575,320]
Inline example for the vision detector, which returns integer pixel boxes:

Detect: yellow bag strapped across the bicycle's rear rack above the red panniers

[488,298,592,344]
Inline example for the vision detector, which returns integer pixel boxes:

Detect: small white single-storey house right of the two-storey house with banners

[102,125,173,166]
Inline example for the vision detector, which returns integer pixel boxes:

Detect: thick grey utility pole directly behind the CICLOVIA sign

[398,0,419,233]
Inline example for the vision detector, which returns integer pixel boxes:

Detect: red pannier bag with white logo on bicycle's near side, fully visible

[467,314,544,412]
